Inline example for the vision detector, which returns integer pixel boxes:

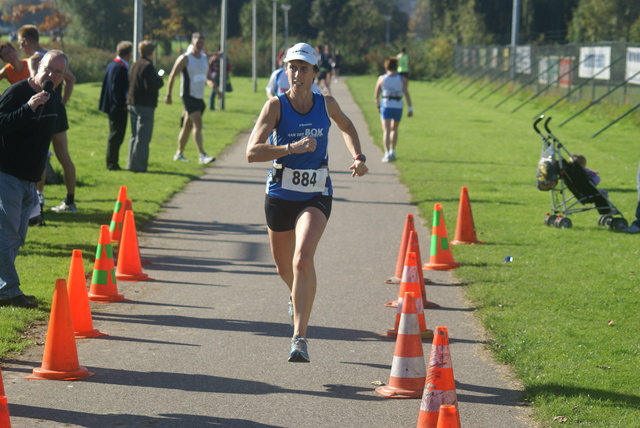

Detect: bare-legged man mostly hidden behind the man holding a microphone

[18,25,78,213]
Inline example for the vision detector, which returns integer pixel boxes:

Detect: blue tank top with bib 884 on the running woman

[266,92,333,201]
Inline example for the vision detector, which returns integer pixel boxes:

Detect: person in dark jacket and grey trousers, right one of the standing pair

[127,40,164,172]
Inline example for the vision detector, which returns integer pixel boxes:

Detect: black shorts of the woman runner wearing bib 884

[264,195,333,232]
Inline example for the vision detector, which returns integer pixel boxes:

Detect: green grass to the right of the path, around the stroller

[347,77,640,427]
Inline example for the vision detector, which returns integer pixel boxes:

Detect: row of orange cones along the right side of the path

[376,187,482,428]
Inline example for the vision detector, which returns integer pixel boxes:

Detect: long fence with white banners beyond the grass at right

[450,43,640,135]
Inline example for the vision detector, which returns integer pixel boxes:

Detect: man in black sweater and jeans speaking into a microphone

[0,50,68,308]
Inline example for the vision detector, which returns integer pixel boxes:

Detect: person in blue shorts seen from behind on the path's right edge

[374,57,413,162]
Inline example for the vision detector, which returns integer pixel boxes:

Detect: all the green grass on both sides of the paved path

[0,77,640,428]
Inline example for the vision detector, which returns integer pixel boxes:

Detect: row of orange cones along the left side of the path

[15,186,150,384]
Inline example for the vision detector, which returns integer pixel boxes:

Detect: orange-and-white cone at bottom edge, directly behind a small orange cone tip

[417,327,458,428]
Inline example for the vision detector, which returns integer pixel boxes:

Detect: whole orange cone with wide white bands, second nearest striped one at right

[376,293,426,398]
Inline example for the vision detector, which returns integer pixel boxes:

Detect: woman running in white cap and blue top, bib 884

[247,43,368,363]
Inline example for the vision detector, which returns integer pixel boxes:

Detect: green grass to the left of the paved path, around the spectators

[0,78,266,358]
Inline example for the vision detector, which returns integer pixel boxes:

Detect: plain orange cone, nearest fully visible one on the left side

[27,279,93,380]
